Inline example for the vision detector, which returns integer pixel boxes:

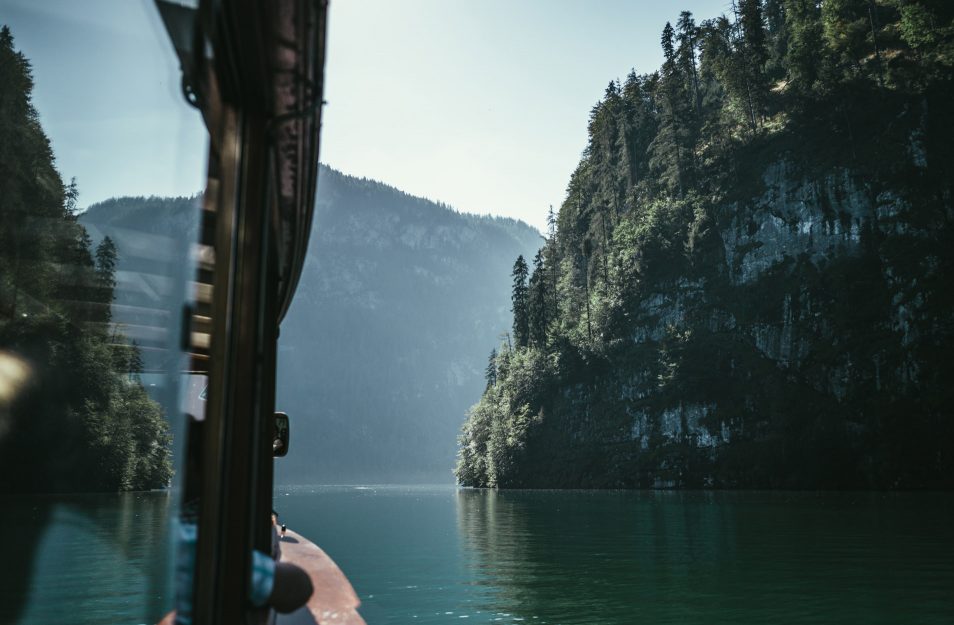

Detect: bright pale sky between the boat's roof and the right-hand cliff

[321,0,728,230]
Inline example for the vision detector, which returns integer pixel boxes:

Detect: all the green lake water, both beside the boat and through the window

[0,486,954,625]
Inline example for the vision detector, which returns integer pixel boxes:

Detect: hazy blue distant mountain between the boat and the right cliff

[276,167,541,483]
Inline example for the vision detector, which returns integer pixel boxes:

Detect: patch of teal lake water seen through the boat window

[0,493,173,625]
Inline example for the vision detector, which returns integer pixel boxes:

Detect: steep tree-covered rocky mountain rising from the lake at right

[457,0,954,488]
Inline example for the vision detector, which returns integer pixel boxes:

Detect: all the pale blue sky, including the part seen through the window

[0,0,728,229]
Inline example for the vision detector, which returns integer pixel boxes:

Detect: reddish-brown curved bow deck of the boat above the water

[276,530,365,625]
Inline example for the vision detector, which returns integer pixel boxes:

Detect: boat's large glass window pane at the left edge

[0,0,207,623]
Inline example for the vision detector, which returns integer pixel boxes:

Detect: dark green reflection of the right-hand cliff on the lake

[457,490,954,625]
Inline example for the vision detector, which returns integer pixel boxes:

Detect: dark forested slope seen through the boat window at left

[0,26,172,492]
